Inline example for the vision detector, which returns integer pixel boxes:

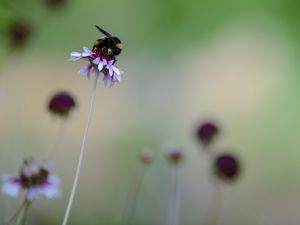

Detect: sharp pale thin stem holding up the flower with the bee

[62,77,98,225]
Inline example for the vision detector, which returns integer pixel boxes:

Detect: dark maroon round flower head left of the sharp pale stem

[48,91,76,117]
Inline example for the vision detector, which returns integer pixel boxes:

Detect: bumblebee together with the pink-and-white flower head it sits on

[70,25,123,86]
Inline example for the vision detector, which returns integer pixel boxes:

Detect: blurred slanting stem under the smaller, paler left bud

[121,165,146,225]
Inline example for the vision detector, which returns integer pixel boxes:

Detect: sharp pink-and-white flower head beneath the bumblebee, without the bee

[70,44,123,87]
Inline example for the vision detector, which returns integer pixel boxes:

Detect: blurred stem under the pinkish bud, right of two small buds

[168,165,180,225]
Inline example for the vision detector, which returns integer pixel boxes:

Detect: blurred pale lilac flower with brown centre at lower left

[2,159,61,201]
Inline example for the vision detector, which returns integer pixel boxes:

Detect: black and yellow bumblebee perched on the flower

[93,25,123,57]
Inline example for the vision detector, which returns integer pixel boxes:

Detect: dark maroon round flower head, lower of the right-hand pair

[214,154,240,181]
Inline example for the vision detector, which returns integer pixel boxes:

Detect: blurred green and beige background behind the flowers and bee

[0,0,300,225]
